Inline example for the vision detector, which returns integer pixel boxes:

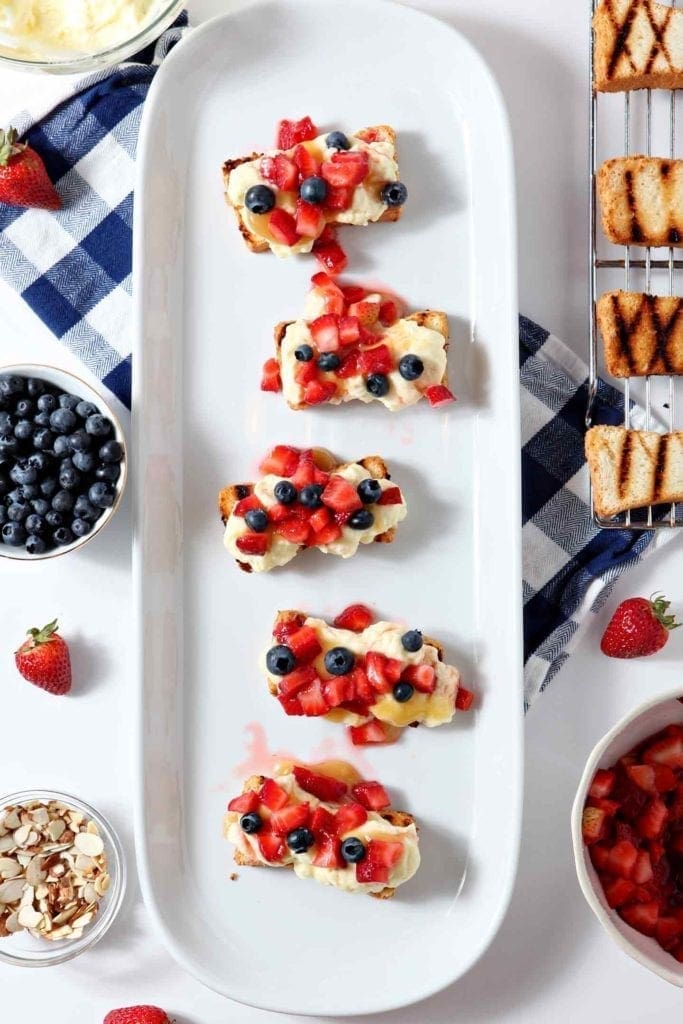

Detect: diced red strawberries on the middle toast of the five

[232,444,402,561]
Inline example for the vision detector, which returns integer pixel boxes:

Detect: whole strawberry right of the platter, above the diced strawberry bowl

[600,594,681,657]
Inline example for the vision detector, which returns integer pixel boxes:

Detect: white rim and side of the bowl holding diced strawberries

[571,684,683,988]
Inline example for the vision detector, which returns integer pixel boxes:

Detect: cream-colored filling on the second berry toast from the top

[280,314,446,412]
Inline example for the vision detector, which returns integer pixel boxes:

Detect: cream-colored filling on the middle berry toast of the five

[223,462,408,572]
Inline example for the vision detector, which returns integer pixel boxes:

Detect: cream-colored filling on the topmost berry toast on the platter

[227,135,398,256]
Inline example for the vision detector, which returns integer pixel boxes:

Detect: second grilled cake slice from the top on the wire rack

[597,157,683,246]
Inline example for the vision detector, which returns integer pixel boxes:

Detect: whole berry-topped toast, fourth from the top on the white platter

[262,604,473,745]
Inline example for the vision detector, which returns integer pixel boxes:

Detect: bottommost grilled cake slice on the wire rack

[586,426,683,516]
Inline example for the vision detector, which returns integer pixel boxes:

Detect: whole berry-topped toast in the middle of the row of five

[218,444,408,572]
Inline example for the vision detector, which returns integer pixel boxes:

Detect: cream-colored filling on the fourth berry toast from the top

[261,617,460,728]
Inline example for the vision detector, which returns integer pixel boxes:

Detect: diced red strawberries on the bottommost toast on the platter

[227,765,403,883]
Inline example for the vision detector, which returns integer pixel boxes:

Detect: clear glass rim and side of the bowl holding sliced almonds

[0,790,126,967]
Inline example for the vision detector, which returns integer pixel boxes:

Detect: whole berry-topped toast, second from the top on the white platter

[261,271,455,412]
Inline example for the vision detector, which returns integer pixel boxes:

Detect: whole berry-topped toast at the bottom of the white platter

[223,761,420,899]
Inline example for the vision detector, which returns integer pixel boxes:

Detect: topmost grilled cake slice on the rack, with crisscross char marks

[593,0,683,92]
